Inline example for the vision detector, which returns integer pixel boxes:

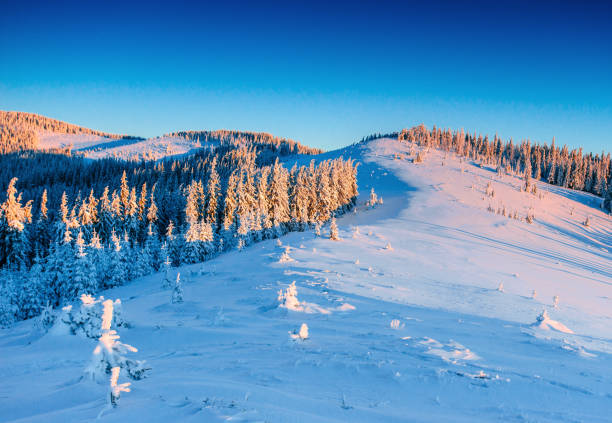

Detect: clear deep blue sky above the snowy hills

[0,0,612,152]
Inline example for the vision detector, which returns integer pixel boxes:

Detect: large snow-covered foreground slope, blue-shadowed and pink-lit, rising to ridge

[0,139,612,422]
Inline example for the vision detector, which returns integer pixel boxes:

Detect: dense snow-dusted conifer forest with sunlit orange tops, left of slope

[0,126,357,324]
